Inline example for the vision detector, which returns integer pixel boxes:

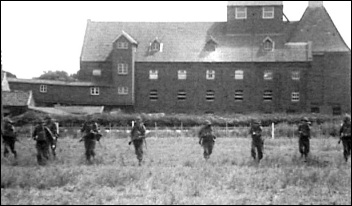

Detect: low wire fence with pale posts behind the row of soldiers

[16,122,340,139]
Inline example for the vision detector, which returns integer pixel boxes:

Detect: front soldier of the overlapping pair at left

[32,121,53,165]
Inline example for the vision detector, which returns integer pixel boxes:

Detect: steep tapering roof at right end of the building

[290,6,350,52]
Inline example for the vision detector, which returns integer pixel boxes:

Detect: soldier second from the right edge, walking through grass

[298,118,310,160]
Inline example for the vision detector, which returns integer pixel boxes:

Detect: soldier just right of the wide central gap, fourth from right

[198,120,216,160]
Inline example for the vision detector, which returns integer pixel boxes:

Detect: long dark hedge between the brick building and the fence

[8,111,343,127]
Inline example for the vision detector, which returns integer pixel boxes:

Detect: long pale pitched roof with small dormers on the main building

[81,21,308,62]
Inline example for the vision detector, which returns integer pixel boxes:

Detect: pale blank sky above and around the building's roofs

[1,1,351,78]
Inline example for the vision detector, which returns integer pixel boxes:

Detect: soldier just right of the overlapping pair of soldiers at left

[80,121,101,162]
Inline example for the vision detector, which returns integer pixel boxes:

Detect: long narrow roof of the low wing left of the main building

[8,78,106,87]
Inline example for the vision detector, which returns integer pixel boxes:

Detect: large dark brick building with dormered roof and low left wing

[9,1,351,114]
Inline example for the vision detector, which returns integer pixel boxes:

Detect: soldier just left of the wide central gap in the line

[128,117,146,166]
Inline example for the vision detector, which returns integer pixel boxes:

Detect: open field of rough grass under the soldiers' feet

[1,138,351,205]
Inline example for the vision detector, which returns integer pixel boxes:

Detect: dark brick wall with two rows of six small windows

[135,63,310,113]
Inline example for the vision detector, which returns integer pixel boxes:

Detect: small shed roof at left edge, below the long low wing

[1,91,33,106]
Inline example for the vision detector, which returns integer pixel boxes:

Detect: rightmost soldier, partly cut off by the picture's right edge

[340,116,351,162]
